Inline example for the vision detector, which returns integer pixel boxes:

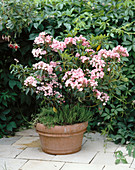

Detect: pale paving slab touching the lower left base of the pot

[17,147,55,160]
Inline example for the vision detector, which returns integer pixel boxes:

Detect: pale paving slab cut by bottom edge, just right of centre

[61,163,104,170]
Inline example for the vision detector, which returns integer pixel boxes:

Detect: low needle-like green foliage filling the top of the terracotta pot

[34,104,93,127]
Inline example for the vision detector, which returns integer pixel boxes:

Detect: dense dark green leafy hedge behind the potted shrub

[0,0,135,143]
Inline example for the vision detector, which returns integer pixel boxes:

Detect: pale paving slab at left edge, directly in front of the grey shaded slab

[0,145,23,158]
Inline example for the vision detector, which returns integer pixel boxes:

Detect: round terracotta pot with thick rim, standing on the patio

[36,122,88,155]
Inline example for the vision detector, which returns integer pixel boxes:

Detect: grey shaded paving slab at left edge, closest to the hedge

[0,136,21,145]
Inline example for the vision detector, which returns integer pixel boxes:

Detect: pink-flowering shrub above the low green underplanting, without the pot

[10,32,129,121]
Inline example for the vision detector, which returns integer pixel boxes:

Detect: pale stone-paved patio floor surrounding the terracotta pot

[0,129,135,170]
